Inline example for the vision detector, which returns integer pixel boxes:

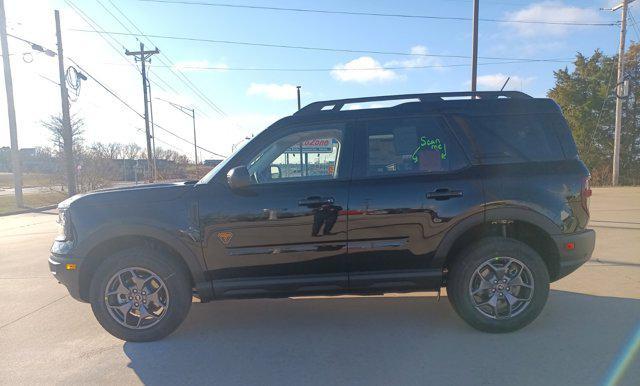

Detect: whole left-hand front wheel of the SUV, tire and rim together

[90,248,191,342]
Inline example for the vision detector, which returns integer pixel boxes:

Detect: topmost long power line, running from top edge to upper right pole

[138,0,618,27]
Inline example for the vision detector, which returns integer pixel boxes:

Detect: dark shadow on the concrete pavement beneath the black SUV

[124,290,640,385]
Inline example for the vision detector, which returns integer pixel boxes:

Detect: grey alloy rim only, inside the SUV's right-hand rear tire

[469,257,534,319]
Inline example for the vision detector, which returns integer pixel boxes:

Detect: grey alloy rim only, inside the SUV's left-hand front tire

[104,267,169,330]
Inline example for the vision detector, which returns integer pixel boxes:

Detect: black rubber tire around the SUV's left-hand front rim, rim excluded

[89,247,192,342]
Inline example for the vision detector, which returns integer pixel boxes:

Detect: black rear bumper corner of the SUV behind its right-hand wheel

[552,229,596,280]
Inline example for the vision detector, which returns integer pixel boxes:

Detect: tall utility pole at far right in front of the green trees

[611,0,634,186]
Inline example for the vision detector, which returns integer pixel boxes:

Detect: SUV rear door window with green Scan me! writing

[366,117,466,176]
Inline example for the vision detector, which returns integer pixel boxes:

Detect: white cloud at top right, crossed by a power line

[505,1,603,38]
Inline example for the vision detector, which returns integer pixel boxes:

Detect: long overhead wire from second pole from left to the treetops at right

[69,28,572,62]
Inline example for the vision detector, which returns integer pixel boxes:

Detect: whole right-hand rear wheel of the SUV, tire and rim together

[447,237,549,332]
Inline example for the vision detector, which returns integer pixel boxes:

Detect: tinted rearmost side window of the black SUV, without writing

[454,114,564,164]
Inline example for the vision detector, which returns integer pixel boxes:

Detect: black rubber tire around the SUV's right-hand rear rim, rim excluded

[447,237,549,333]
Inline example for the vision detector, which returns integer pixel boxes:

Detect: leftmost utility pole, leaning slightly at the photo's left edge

[0,0,24,208]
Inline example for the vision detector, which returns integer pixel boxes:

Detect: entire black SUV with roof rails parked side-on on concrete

[49,92,595,341]
